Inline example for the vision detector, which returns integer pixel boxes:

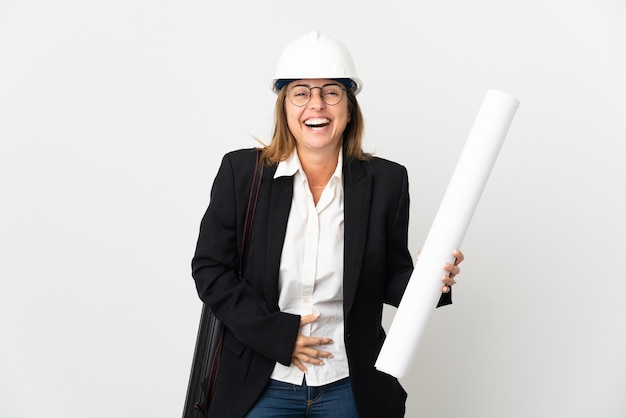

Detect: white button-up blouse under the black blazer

[271,151,349,386]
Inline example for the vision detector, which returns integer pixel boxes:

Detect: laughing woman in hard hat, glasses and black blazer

[192,32,463,418]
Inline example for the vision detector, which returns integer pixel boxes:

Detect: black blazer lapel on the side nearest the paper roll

[343,160,372,316]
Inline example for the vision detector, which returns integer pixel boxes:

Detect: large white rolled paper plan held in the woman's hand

[375,90,519,378]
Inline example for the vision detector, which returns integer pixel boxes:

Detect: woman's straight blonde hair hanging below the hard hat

[261,88,372,165]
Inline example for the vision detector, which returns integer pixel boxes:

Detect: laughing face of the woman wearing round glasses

[284,79,350,155]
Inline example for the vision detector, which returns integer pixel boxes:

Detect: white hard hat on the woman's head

[271,30,363,94]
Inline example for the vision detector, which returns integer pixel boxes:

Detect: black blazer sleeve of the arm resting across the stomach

[191,153,300,365]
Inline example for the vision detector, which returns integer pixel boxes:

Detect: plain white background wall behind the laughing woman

[0,0,626,418]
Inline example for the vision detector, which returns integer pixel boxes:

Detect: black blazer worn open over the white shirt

[192,149,450,418]
